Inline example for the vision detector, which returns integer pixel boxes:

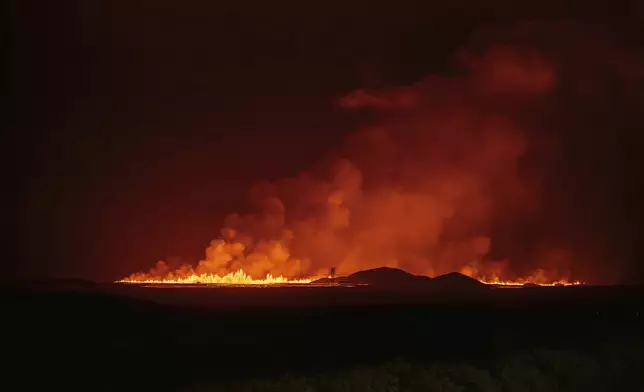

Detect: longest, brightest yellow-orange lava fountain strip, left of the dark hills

[118,269,313,286]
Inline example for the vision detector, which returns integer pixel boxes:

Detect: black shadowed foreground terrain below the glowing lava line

[2,282,644,391]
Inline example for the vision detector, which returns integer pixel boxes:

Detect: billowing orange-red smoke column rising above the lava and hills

[124,23,641,282]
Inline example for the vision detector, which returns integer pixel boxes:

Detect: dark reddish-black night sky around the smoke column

[6,0,644,280]
